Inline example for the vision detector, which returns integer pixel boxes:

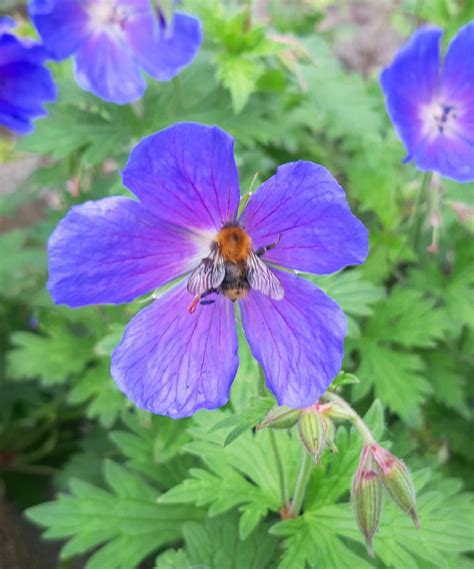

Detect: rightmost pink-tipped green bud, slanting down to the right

[370,444,420,528]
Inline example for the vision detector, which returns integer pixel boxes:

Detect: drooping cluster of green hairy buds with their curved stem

[257,392,419,555]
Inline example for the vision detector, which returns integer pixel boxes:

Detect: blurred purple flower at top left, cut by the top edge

[30,0,202,104]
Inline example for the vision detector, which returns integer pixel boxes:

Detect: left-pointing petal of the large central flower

[48,197,206,307]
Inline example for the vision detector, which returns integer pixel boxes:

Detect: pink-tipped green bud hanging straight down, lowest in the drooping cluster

[351,446,383,557]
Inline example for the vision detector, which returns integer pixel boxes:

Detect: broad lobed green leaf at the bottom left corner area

[27,461,201,569]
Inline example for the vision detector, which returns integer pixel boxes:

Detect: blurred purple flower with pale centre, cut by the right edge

[381,22,474,182]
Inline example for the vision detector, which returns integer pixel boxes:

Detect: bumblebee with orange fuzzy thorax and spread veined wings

[188,223,284,313]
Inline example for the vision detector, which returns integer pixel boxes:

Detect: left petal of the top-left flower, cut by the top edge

[29,0,90,60]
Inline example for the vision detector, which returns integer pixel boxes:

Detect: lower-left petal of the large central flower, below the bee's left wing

[112,283,239,417]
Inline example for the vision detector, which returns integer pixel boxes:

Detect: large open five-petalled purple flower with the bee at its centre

[48,123,368,417]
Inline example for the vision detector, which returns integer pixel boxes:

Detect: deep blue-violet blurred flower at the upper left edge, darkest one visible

[0,17,56,134]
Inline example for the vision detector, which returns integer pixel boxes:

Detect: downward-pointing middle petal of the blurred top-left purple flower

[72,33,146,105]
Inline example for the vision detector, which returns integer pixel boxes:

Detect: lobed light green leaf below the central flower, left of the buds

[160,412,301,536]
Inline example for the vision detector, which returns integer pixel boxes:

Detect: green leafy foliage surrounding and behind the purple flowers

[0,0,474,569]
